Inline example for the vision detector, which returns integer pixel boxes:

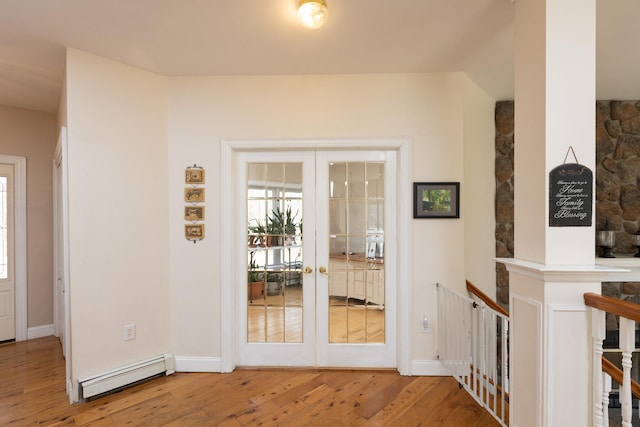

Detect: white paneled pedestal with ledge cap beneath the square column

[499,258,612,427]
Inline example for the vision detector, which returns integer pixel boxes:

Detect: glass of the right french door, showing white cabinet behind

[328,162,385,344]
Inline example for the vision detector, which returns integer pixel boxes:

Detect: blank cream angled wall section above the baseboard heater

[66,50,170,380]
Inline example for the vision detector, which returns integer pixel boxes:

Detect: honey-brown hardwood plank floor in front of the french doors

[0,337,499,427]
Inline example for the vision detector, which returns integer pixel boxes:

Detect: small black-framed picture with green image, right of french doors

[413,182,460,218]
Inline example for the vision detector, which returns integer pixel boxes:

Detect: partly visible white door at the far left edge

[0,164,16,341]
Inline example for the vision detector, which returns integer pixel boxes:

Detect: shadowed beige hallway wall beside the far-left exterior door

[0,106,57,328]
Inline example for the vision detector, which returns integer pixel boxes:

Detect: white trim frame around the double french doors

[220,138,412,375]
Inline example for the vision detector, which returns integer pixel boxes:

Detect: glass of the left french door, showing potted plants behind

[247,163,303,343]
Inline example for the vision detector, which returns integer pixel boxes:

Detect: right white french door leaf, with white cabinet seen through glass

[316,151,397,368]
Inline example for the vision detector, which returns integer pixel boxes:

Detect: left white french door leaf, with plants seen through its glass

[237,152,316,366]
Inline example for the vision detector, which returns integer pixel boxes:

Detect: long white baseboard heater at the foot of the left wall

[79,353,175,399]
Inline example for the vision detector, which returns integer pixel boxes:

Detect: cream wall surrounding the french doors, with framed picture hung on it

[169,73,494,360]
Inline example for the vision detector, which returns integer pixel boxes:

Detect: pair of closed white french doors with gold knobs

[236,151,396,367]
